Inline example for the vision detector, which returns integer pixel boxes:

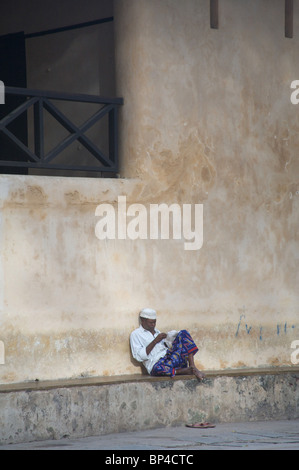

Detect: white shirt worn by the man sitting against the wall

[130,325,167,374]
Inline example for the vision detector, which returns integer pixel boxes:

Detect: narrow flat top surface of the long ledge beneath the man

[0,366,299,393]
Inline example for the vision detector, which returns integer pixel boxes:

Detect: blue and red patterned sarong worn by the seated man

[151,330,198,377]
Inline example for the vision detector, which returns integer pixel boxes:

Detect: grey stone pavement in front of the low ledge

[0,420,299,455]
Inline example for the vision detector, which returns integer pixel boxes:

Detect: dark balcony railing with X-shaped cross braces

[0,87,123,174]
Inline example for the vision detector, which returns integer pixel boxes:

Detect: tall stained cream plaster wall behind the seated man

[0,0,299,383]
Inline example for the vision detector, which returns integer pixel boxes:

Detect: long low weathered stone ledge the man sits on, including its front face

[0,367,299,445]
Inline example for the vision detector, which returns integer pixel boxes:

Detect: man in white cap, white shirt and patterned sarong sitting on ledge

[130,308,205,379]
